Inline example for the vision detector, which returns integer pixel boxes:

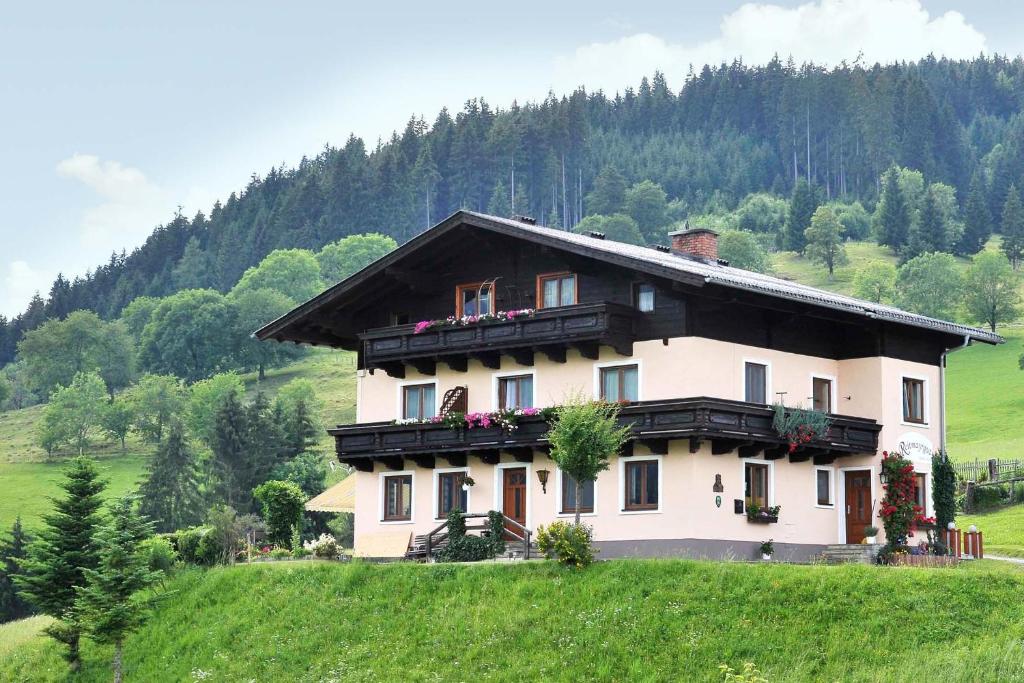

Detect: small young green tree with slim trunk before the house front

[548,398,630,524]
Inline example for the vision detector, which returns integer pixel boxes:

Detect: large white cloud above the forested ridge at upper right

[555,0,986,91]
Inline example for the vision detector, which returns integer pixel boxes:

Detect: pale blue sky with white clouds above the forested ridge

[0,0,1024,316]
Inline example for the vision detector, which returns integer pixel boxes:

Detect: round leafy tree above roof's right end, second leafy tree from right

[896,254,964,321]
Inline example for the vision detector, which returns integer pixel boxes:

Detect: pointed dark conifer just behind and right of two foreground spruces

[139,422,204,531]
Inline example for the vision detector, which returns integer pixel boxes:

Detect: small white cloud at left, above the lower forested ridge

[56,154,174,249]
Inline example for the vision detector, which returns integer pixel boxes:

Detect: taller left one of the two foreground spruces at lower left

[14,457,106,671]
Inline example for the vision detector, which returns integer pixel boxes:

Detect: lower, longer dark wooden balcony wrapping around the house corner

[328,397,882,471]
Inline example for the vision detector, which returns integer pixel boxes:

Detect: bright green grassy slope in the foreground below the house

[0,560,1024,682]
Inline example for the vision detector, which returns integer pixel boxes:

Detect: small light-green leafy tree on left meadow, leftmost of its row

[37,372,106,455]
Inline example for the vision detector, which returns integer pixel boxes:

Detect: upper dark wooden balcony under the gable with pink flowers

[359,302,636,378]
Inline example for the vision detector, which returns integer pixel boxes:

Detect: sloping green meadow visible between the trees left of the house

[0,349,355,531]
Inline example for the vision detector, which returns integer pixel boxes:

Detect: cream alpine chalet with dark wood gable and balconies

[257,211,1001,560]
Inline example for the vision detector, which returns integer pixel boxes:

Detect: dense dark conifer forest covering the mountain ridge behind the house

[0,56,1024,366]
